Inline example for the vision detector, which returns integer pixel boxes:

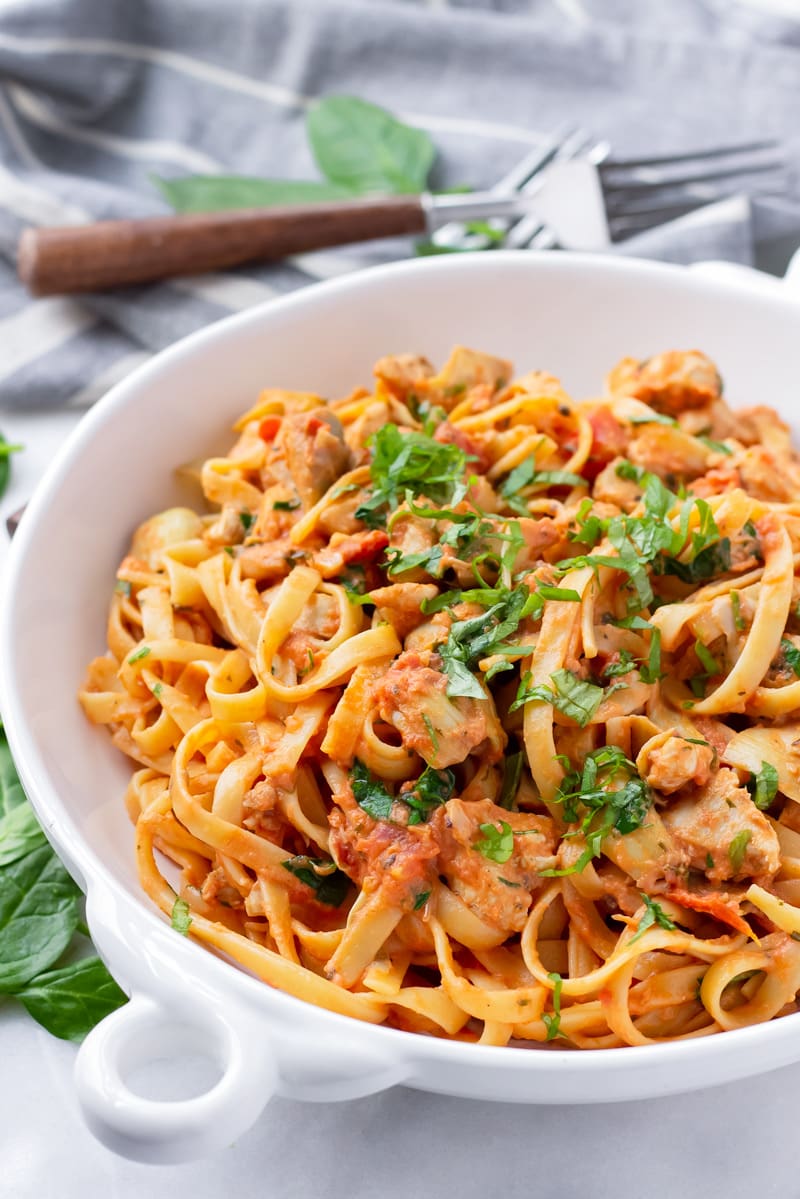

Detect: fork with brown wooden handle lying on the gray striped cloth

[17,131,783,295]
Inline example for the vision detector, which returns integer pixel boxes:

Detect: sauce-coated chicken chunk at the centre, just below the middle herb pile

[377,651,506,770]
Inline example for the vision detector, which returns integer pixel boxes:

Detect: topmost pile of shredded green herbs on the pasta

[355,424,471,529]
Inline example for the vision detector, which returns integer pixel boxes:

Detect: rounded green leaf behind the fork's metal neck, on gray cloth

[306,96,435,194]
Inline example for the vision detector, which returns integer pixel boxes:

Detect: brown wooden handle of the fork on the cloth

[17,195,426,296]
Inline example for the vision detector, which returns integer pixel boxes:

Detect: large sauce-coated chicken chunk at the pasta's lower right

[661,767,781,882]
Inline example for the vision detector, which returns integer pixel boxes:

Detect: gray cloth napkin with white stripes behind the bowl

[0,0,800,408]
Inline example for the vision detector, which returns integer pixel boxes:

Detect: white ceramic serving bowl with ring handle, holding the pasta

[0,253,800,1162]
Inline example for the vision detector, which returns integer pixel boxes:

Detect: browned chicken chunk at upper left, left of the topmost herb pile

[265,408,353,508]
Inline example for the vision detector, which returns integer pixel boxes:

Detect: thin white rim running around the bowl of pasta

[6,251,800,1077]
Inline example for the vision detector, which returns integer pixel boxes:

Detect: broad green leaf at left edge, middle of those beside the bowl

[0,844,80,992]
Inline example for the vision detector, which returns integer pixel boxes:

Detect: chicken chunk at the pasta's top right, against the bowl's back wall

[606,350,722,416]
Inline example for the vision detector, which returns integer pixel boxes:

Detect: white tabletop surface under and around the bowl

[0,414,800,1199]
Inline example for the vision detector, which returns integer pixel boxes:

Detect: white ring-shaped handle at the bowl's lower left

[76,994,277,1163]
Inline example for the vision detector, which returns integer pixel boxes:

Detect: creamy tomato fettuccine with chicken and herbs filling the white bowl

[79,347,800,1049]
